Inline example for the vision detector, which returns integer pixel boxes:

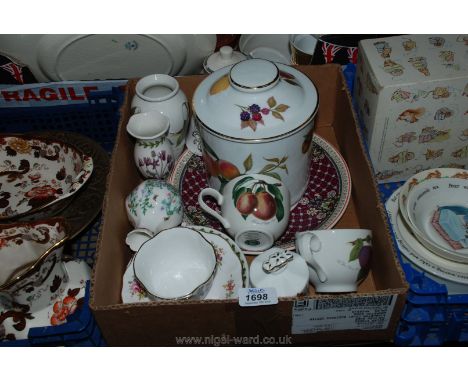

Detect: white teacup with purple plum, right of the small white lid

[296,229,372,293]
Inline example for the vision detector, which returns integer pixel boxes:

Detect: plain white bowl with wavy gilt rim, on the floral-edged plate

[133,227,217,300]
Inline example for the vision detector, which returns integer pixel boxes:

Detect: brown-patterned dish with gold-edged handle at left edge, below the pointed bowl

[0,217,67,310]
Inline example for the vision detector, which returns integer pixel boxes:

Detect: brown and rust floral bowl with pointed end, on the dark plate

[0,135,93,221]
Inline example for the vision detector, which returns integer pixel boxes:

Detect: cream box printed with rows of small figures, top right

[354,35,468,183]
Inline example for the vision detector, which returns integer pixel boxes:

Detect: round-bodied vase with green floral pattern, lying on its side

[125,179,183,251]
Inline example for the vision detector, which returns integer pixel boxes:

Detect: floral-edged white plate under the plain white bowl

[121,226,249,304]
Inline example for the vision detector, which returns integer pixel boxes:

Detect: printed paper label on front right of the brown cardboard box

[291,295,397,334]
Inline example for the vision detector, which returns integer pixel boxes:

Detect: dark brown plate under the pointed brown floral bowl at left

[37,131,110,240]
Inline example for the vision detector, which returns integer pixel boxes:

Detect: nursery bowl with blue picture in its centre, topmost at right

[399,168,468,263]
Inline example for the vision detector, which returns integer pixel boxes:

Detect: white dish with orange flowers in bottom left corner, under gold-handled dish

[0,260,91,344]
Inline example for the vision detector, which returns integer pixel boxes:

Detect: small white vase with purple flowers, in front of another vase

[127,111,174,179]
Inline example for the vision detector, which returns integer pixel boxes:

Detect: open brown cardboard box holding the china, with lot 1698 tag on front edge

[90,65,407,346]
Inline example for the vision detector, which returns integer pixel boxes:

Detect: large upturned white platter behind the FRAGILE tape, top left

[0,34,216,82]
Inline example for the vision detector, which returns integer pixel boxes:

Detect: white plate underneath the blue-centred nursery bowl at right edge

[385,188,468,292]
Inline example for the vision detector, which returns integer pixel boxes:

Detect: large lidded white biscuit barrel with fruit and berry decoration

[193,59,318,205]
